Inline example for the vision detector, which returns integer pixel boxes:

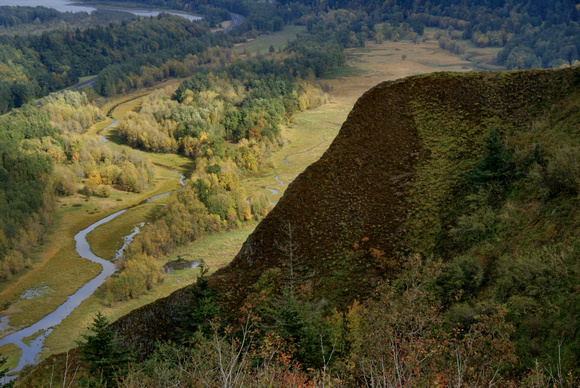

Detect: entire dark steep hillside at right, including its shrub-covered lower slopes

[19,68,580,385]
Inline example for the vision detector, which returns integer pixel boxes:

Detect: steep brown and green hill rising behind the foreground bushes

[114,67,580,376]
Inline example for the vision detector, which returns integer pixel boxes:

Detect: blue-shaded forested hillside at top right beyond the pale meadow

[276,0,580,69]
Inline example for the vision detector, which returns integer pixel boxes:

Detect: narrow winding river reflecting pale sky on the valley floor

[0,119,185,379]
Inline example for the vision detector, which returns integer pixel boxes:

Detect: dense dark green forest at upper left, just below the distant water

[0,14,224,112]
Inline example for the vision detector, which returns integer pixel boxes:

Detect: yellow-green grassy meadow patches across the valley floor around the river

[0,26,497,366]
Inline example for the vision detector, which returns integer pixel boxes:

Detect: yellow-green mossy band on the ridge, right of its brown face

[406,69,580,254]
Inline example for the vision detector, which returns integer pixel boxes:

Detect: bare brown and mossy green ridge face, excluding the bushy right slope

[114,68,580,352]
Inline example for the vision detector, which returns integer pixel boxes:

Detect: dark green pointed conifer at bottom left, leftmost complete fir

[78,312,129,386]
